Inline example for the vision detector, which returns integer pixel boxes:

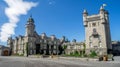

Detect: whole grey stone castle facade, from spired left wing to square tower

[7,6,112,56]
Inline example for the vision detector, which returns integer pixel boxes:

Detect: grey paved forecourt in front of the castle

[0,56,120,67]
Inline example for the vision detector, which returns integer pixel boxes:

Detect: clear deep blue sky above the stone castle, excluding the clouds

[0,0,120,45]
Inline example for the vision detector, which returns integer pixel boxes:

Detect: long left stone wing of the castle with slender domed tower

[7,17,65,56]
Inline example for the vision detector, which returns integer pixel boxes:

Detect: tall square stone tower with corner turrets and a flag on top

[83,6,112,54]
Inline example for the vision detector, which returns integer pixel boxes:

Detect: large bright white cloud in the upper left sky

[0,0,37,42]
